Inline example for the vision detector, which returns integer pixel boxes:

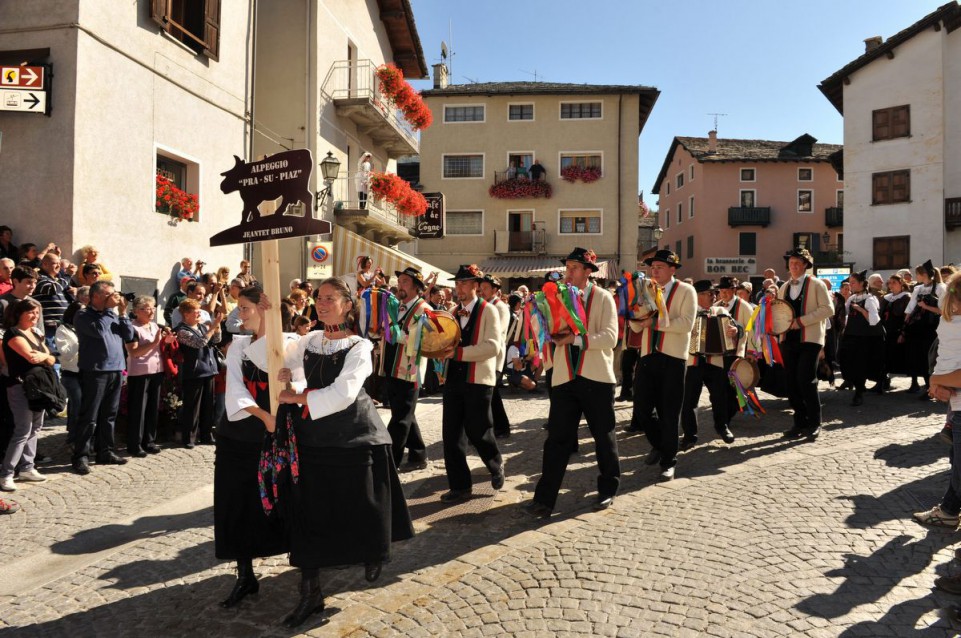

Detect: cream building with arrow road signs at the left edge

[0,0,250,302]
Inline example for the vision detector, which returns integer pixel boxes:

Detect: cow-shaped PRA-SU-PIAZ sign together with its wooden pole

[210,149,331,414]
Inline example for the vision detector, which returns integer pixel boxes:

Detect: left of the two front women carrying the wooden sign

[214,287,296,608]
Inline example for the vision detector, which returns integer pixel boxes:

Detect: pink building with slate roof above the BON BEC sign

[653,131,844,285]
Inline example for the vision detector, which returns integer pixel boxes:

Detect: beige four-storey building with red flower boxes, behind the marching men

[417,65,659,287]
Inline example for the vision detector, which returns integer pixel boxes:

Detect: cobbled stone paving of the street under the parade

[0,380,961,638]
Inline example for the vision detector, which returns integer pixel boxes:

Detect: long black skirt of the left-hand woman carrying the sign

[214,436,287,560]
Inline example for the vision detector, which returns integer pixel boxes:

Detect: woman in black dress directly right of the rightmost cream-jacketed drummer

[838,270,884,405]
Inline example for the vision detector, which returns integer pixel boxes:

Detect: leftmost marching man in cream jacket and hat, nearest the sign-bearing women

[384,266,430,472]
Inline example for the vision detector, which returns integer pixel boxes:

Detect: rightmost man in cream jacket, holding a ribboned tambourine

[777,247,834,441]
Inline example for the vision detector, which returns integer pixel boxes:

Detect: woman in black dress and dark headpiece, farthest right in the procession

[902,259,947,401]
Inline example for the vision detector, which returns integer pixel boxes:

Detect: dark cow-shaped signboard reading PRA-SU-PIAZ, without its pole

[210,149,331,246]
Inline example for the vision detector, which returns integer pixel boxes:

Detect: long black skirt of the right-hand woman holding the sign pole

[281,445,414,568]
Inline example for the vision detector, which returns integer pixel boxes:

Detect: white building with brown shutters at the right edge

[819,2,961,273]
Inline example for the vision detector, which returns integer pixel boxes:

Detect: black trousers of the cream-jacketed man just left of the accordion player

[634,352,687,469]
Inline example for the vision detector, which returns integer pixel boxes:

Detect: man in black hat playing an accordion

[680,277,744,451]
